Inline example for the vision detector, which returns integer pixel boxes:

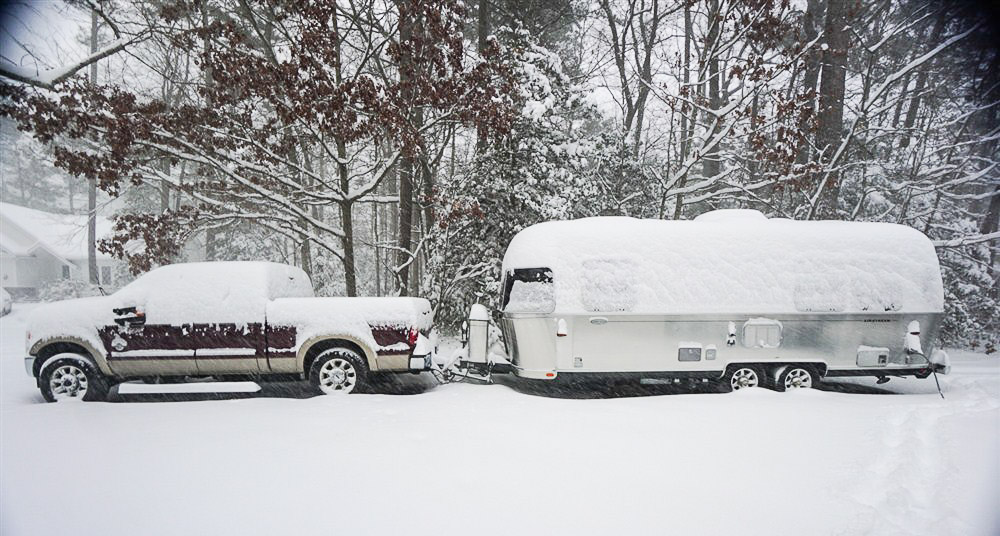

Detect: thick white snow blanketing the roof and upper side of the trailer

[503,210,944,314]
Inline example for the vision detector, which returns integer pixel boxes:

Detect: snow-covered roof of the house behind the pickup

[0,203,111,261]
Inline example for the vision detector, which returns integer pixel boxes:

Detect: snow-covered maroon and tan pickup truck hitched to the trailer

[25,262,432,402]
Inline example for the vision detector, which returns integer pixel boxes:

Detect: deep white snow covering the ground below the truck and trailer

[0,304,1000,535]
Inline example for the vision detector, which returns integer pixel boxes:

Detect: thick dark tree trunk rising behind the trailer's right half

[816,0,848,218]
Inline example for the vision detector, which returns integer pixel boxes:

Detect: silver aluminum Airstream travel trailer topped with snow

[484,210,948,390]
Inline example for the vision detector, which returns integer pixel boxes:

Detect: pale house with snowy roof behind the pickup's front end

[0,203,119,299]
